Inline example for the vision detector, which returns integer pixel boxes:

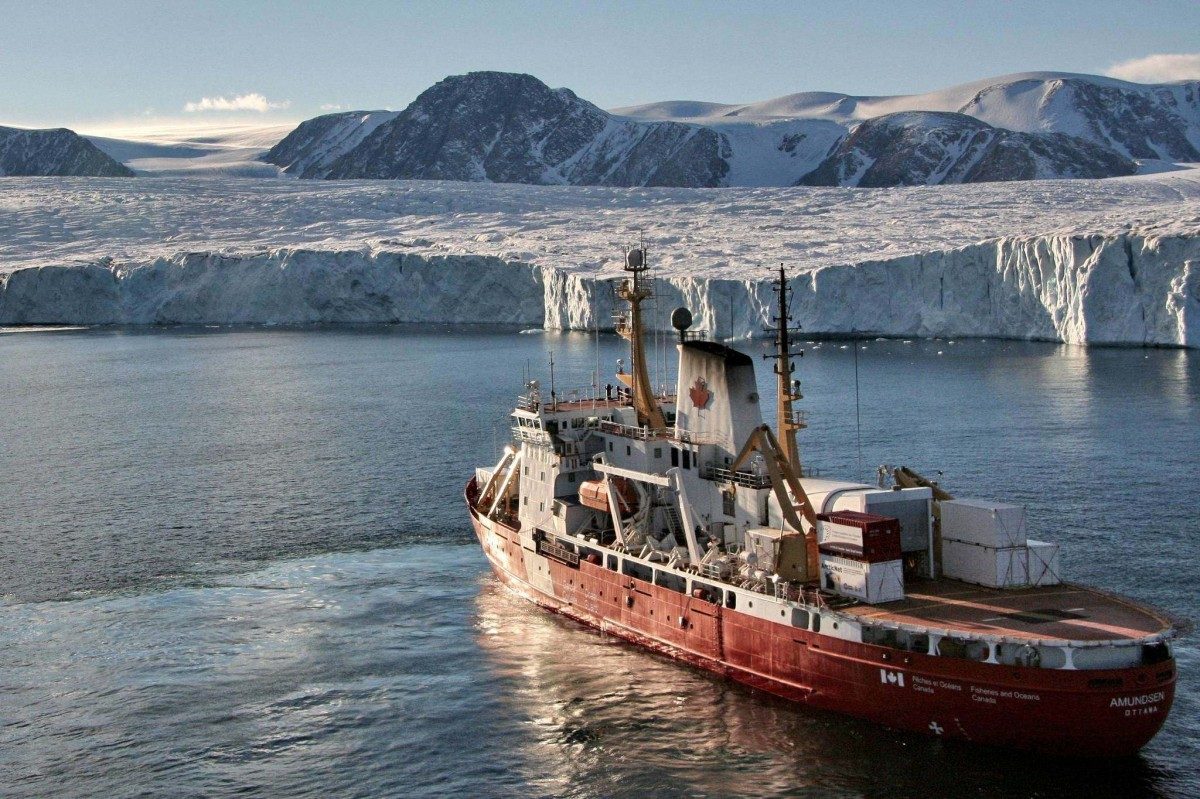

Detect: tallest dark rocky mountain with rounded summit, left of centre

[295,72,728,186]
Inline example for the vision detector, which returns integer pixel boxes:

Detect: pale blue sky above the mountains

[7,0,1200,128]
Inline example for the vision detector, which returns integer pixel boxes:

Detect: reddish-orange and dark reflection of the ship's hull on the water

[475,581,1188,799]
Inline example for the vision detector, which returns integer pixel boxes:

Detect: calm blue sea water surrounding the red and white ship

[0,329,1200,799]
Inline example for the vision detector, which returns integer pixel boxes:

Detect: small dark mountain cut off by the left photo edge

[0,127,133,178]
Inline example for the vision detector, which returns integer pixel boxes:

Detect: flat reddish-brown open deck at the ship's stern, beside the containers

[842,579,1172,642]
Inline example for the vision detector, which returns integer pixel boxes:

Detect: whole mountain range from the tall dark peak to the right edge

[265,72,1200,187]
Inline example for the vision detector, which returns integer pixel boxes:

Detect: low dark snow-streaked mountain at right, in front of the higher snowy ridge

[800,112,1138,188]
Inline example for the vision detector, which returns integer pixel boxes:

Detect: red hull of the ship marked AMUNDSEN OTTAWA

[468,492,1176,757]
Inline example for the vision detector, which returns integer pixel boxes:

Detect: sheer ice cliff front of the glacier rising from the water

[0,233,1200,347]
